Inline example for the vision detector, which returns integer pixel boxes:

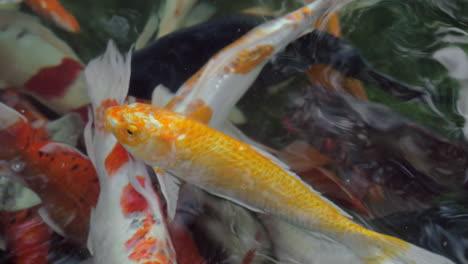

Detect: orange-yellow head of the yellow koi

[106,103,175,165]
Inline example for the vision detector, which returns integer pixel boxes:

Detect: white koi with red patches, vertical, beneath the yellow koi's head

[85,42,176,264]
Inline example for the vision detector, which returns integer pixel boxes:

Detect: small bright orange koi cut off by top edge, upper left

[25,0,80,33]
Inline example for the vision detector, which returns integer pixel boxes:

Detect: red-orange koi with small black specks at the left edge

[0,103,99,243]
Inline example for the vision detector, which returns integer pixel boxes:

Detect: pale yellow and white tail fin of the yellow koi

[347,231,454,264]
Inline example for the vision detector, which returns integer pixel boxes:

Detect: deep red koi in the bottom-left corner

[0,206,52,264]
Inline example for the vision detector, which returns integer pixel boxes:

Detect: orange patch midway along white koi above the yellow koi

[225,45,275,74]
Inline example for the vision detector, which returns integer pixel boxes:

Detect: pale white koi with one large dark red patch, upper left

[0,10,89,113]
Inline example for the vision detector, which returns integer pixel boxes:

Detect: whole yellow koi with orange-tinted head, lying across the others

[106,103,453,264]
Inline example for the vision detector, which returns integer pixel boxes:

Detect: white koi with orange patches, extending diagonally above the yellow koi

[167,0,349,127]
